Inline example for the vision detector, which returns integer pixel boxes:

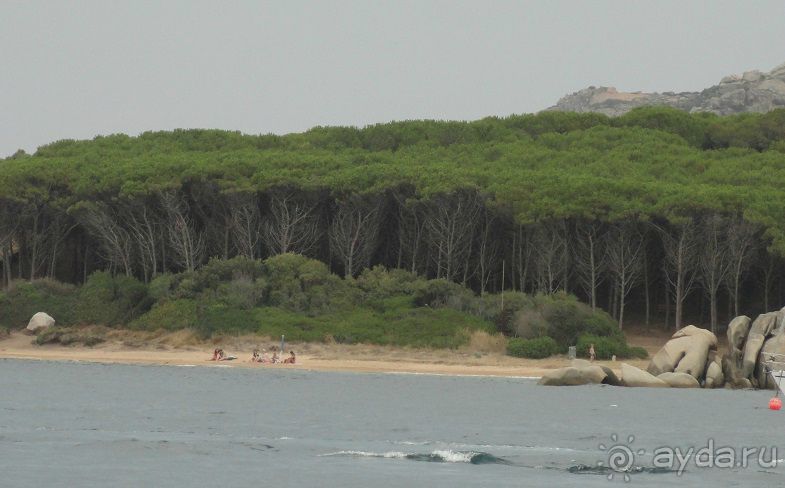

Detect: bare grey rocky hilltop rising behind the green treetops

[548,63,785,116]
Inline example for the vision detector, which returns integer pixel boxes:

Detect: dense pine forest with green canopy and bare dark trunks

[0,107,785,338]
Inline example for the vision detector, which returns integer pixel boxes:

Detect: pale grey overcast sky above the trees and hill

[0,0,785,157]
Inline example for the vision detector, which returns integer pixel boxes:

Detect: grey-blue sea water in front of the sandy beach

[0,360,785,488]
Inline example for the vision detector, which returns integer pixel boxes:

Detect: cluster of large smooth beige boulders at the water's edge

[539,308,785,388]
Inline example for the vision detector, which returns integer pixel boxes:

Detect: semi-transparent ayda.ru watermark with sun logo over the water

[597,434,782,481]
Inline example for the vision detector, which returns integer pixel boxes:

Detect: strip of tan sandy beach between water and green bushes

[0,331,664,377]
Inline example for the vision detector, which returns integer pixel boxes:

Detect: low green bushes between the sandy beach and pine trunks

[0,254,645,358]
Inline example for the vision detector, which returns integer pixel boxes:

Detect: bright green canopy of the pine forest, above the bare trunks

[0,107,785,251]
